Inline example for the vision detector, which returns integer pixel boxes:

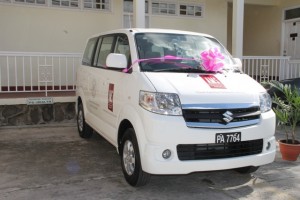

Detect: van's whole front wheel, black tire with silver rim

[120,128,151,187]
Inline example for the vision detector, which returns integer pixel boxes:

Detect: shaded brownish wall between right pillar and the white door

[244,5,282,56]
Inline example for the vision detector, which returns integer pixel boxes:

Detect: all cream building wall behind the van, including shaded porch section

[0,0,300,55]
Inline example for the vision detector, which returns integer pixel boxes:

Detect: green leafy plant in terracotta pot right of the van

[270,81,300,161]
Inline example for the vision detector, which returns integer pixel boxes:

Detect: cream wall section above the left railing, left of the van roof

[0,0,122,52]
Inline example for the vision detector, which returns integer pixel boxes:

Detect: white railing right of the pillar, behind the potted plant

[243,56,300,82]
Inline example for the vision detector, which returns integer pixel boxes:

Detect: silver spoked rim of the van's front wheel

[123,140,135,175]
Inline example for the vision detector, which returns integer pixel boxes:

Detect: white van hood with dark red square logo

[144,72,266,105]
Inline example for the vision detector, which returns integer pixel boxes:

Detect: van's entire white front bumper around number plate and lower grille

[138,111,276,174]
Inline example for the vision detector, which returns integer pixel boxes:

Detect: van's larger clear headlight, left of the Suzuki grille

[139,91,182,115]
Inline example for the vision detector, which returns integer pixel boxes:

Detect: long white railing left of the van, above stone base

[0,52,82,95]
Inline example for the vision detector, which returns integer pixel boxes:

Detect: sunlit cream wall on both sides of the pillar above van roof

[0,0,227,52]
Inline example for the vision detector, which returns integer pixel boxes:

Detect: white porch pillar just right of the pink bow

[232,0,244,59]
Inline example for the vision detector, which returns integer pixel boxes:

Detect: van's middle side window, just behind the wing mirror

[97,35,114,67]
